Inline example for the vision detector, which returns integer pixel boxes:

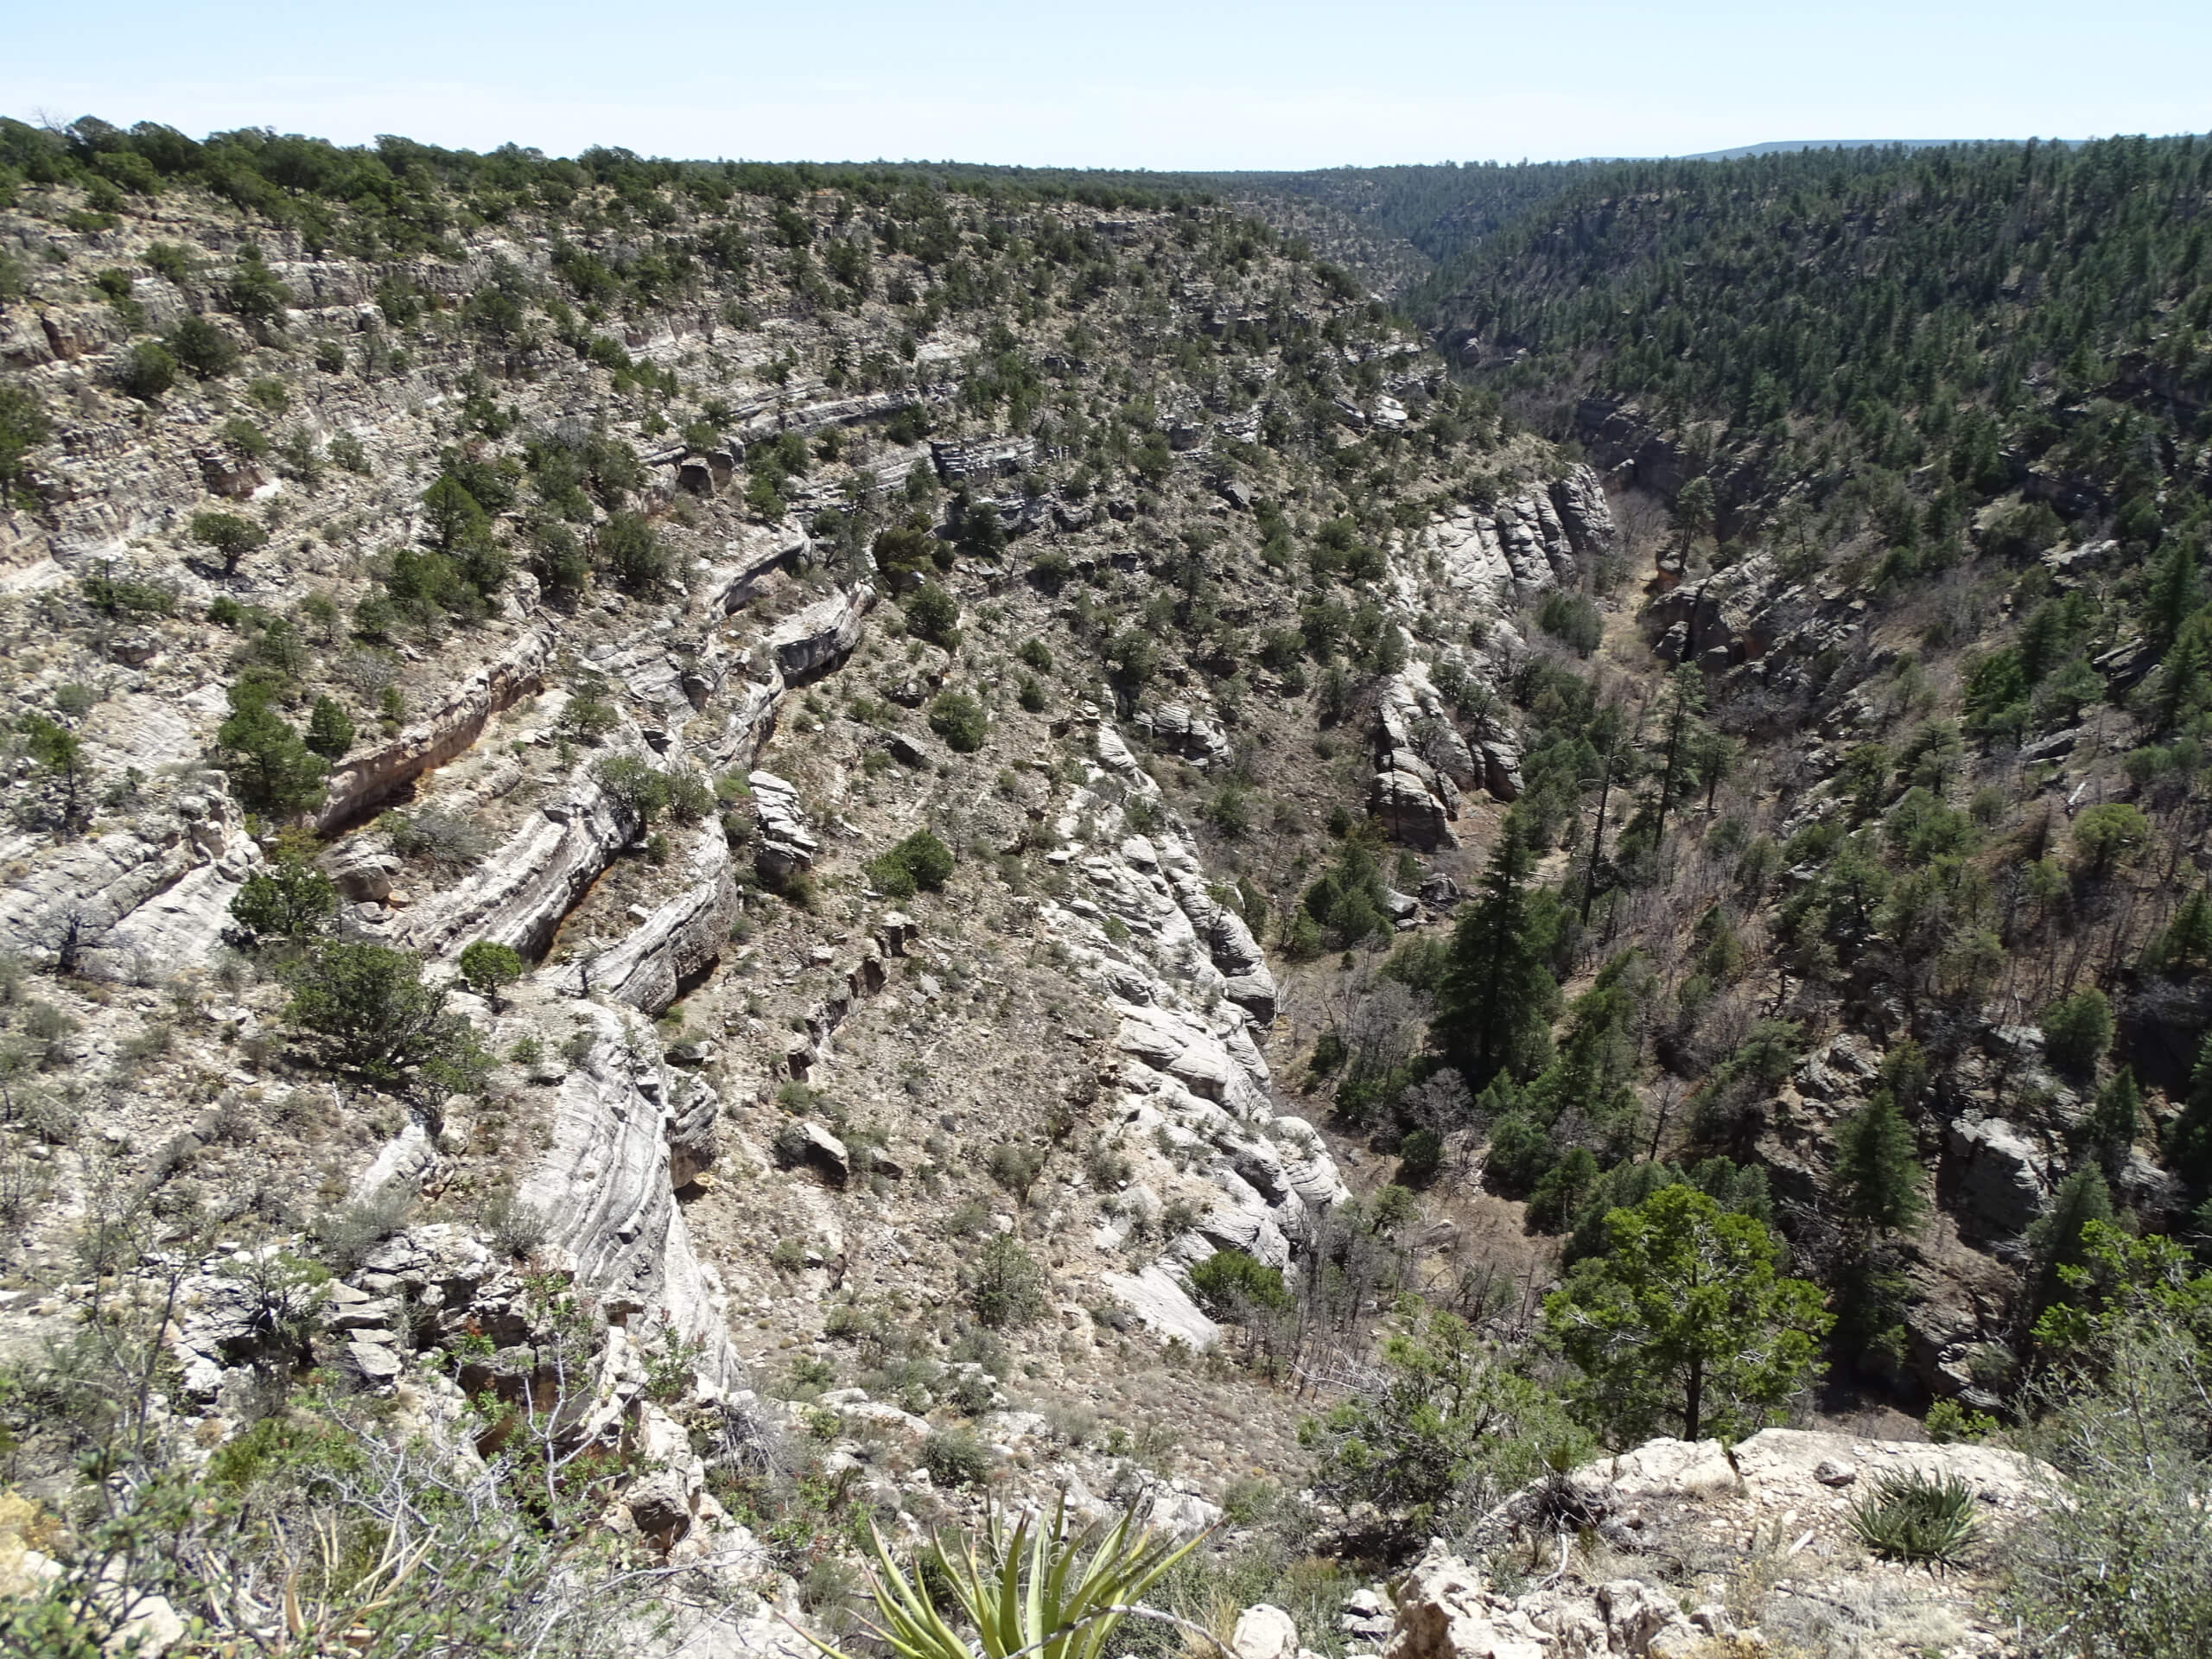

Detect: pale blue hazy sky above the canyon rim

[0,0,2212,168]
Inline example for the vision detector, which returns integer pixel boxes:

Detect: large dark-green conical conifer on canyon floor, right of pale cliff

[1433,814,1560,1089]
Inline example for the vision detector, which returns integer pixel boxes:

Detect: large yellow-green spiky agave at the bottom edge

[801,1496,1219,1659]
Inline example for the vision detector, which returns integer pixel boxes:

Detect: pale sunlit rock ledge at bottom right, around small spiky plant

[1234,1429,2057,1659]
